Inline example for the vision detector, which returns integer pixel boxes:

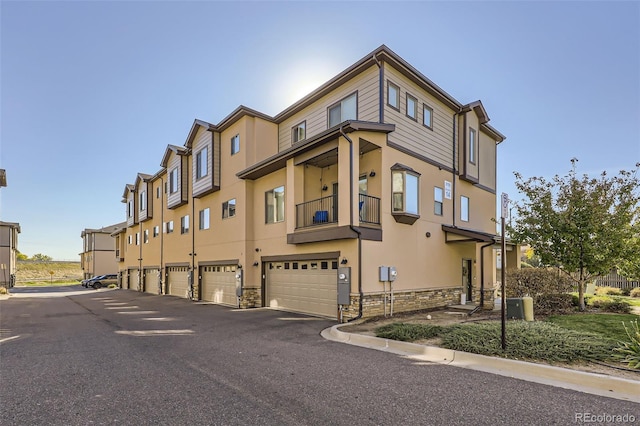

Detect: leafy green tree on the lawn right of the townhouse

[510,158,640,310]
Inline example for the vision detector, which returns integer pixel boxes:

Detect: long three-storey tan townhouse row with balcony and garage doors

[113,46,519,320]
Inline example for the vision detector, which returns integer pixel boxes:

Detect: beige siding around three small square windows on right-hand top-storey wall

[383,63,454,168]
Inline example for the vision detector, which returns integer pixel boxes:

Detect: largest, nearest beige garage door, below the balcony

[265,260,338,318]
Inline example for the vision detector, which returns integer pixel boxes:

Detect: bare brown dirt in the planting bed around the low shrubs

[340,309,640,381]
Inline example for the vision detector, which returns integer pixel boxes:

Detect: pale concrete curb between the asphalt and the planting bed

[321,324,640,402]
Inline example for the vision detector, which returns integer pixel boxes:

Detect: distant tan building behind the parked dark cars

[80,222,127,279]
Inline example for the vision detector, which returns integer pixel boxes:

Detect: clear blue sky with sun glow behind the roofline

[0,0,640,260]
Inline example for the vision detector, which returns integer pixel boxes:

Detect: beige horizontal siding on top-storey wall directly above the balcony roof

[278,65,379,151]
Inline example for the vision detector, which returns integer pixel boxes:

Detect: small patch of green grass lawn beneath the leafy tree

[547,314,640,341]
